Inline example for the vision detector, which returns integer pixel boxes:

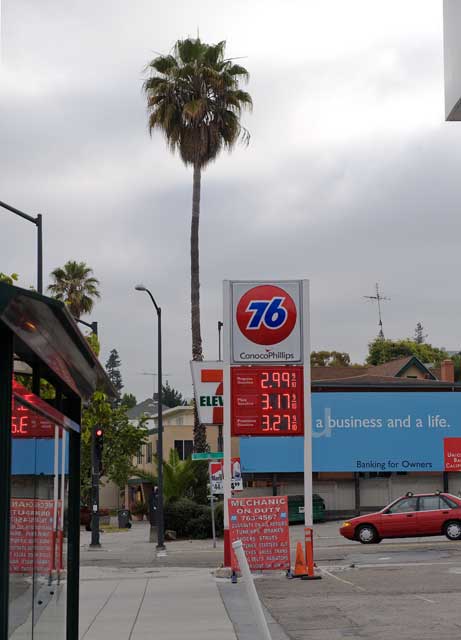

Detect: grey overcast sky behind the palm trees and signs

[0,0,461,400]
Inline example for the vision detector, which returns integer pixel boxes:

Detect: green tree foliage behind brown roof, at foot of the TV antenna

[366,337,448,365]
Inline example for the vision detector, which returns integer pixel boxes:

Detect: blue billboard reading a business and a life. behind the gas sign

[240,392,461,473]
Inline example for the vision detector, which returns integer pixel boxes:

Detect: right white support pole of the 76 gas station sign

[302,280,313,527]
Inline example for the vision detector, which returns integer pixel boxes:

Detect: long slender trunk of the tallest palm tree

[190,162,207,452]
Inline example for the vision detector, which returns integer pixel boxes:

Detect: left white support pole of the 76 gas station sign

[223,280,232,567]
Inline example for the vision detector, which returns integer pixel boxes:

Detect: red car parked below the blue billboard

[339,492,461,544]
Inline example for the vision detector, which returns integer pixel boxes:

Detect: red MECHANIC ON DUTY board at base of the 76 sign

[229,496,290,571]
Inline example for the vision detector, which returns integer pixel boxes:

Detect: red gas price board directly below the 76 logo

[231,366,304,436]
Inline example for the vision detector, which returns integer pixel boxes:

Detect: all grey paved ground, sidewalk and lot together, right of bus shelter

[77,522,461,640]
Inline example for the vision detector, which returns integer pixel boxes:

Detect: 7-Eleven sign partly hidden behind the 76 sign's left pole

[190,361,224,425]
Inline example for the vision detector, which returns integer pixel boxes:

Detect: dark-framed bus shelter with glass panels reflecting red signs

[0,283,114,640]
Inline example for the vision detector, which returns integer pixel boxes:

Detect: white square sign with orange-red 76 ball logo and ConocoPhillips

[230,280,303,364]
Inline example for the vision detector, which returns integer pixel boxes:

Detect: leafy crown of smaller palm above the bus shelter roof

[48,260,101,318]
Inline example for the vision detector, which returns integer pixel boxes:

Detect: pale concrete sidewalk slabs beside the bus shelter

[80,567,236,640]
